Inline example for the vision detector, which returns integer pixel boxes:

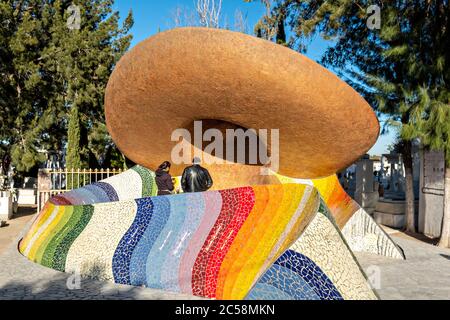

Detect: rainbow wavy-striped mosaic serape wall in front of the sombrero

[19,167,376,300]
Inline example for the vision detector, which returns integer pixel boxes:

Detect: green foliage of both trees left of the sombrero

[0,0,133,175]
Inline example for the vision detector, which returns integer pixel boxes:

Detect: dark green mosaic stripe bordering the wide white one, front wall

[51,205,94,272]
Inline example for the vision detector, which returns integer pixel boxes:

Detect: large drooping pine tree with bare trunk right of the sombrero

[255,0,450,240]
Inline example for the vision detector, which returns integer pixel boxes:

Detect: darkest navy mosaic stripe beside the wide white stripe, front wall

[112,198,153,284]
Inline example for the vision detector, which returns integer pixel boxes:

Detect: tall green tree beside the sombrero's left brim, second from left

[48,0,133,167]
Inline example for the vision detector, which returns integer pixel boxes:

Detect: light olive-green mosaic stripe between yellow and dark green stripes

[40,206,76,268]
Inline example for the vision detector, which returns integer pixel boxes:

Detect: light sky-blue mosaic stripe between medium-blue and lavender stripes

[146,194,187,289]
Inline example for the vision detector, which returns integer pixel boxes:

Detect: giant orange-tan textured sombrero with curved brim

[105,28,379,184]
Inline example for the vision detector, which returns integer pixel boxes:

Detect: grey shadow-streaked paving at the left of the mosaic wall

[0,210,200,300]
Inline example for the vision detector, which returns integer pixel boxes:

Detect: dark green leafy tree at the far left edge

[0,0,54,171]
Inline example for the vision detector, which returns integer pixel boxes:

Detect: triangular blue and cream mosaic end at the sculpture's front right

[246,199,378,300]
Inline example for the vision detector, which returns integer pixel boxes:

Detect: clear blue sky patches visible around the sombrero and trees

[114,0,395,155]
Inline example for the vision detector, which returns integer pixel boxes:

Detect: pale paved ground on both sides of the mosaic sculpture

[0,208,450,300]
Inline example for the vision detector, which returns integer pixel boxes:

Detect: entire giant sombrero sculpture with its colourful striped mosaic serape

[20,28,402,299]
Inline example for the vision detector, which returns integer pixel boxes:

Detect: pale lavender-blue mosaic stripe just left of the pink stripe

[161,193,207,292]
